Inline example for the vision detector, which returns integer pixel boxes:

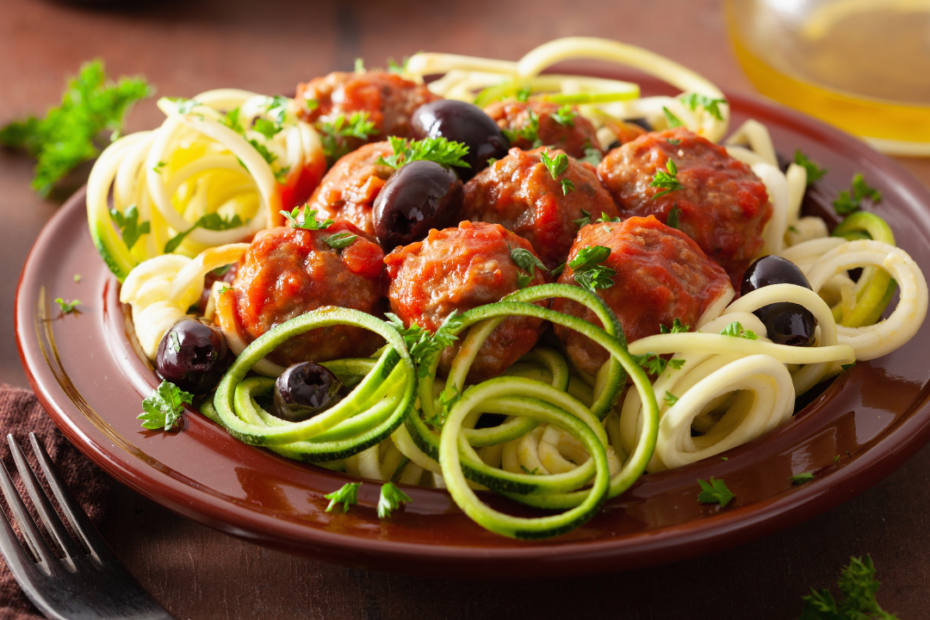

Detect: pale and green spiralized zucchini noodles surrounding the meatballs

[99,37,928,539]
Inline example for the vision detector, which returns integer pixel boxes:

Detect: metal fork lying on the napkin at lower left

[0,433,173,620]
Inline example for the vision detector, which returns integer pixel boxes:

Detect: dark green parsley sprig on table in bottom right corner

[801,555,898,620]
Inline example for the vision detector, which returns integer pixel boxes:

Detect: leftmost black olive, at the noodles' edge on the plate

[155,317,232,394]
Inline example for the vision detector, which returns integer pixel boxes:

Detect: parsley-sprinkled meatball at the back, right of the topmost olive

[484,99,601,157]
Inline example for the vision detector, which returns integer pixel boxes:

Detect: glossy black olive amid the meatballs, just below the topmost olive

[371,161,465,250]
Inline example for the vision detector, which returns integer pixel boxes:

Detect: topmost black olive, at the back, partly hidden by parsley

[410,99,510,181]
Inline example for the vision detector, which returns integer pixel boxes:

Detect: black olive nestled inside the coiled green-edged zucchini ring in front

[274,362,342,422]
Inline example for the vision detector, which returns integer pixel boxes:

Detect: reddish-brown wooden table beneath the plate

[0,0,930,620]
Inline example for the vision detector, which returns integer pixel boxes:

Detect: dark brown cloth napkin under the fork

[0,384,112,620]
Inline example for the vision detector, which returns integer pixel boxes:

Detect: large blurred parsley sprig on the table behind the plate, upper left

[0,60,153,196]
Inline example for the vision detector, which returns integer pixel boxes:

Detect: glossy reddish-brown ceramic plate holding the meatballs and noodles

[16,74,930,578]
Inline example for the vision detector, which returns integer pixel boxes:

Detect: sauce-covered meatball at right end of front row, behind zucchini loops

[553,216,733,375]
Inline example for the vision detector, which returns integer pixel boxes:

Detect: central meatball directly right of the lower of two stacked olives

[462,148,617,269]
